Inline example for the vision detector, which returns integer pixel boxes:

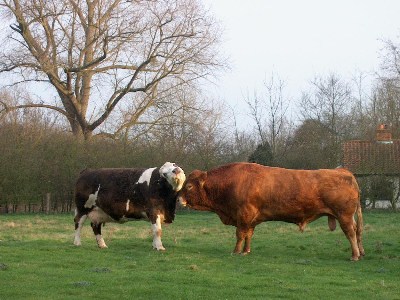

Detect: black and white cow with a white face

[74,162,186,250]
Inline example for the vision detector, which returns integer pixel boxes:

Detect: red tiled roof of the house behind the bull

[343,139,400,175]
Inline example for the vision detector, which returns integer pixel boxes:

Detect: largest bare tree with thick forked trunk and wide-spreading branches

[0,0,223,139]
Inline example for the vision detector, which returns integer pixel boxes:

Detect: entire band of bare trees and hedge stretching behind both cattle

[0,71,400,212]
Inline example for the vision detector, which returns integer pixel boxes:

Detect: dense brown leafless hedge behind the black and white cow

[0,119,247,213]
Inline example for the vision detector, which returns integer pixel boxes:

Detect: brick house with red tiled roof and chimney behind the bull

[343,124,400,208]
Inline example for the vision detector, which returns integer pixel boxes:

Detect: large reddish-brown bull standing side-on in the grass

[178,163,365,260]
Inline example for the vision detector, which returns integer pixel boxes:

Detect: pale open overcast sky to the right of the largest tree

[204,0,400,128]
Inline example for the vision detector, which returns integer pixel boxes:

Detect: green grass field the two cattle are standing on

[0,212,400,299]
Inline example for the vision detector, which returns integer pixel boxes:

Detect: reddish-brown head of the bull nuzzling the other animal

[178,170,207,210]
